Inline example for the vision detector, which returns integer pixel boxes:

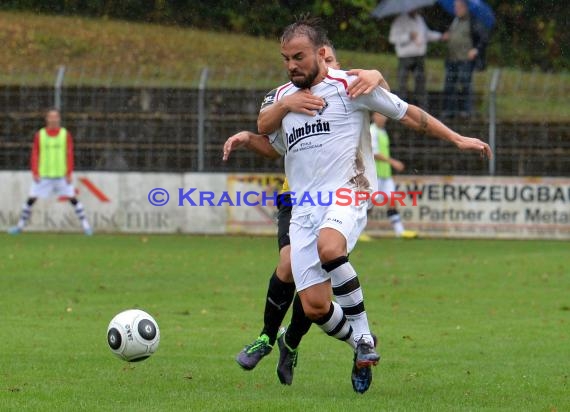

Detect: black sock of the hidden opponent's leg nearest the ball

[261,272,295,345]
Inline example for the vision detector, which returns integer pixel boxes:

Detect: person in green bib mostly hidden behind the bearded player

[370,113,418,239]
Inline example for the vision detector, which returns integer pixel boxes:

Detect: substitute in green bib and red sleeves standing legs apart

[9,109,93,235]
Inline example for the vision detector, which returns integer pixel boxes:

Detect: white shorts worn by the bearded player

[289,202,367,291]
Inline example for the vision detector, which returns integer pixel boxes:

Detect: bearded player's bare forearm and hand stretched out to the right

[400,104,493,159]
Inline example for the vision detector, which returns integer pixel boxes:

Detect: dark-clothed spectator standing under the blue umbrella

[440,0,494,118]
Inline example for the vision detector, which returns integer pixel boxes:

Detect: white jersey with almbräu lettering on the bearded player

[262,69,408,215]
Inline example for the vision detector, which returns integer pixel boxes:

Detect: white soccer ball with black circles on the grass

[107,309,160,362]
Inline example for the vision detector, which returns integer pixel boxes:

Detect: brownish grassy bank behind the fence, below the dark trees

[0,12,570,121]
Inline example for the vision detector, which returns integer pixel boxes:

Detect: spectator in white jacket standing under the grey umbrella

[389,10,442,109]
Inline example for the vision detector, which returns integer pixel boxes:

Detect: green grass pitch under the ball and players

[0,234,570,412]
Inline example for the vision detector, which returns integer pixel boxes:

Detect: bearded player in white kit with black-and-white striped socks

[258,16,491,392]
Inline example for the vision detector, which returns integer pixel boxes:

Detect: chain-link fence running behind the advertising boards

[0,67,570,176]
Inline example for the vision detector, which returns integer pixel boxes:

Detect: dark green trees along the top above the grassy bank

[0,0,570,70]
